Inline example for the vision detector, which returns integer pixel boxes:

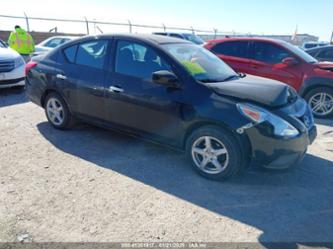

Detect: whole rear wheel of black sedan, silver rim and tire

[45,92,74,129]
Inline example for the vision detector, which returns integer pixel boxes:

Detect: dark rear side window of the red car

[212,41,248,58]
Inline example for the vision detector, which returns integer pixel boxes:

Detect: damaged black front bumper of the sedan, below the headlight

[246,126,317,169]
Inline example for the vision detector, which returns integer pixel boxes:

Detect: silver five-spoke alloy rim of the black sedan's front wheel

[191,136,229,174]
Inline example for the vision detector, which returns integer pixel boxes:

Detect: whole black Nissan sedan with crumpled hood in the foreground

[26,35,316,179]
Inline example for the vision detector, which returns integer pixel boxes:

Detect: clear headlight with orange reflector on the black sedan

[237,104,299,137]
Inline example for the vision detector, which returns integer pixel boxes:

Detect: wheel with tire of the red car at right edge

[305,87,333,118]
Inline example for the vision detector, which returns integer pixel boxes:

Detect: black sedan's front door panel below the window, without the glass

[107,74,180,137]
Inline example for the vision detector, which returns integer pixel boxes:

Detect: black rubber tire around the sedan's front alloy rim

[186,126,246,180]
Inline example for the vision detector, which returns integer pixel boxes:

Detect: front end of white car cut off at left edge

[0,40,25,88]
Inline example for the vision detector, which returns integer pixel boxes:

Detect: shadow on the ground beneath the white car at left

[0,87,28,108]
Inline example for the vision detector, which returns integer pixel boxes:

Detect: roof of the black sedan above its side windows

[86,34,192,45]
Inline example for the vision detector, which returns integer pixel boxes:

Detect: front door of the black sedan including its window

[106,41,182,139]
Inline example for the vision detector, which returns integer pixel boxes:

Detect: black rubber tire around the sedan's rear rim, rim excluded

[44,92,75,130]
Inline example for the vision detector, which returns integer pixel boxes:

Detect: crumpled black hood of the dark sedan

[207,75,297,107]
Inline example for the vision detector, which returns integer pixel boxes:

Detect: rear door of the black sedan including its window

[57,40,108,119]
